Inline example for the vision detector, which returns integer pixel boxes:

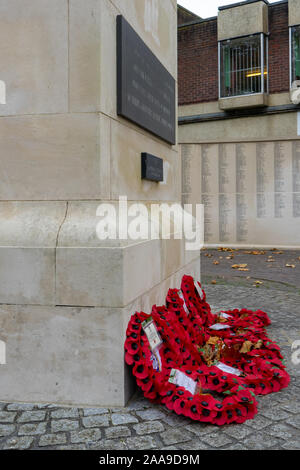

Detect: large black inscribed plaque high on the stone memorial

[117,15,176,145]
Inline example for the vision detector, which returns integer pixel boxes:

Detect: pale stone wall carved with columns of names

[181,141,300,247]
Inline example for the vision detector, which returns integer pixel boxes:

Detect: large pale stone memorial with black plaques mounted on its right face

[0,0,200,406]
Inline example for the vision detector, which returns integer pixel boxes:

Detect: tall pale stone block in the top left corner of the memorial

[0,0,68,116]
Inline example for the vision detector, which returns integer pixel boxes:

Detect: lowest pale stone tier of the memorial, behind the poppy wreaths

[0,258,200,406]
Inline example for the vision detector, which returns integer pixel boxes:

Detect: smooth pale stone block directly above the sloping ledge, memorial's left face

[0,114,104,200]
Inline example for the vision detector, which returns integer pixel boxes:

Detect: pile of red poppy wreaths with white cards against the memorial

[125,276,290,425]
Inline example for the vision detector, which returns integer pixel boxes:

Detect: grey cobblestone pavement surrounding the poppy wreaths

[0,282,300,450]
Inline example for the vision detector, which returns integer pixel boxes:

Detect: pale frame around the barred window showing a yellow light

[218,33,269,100]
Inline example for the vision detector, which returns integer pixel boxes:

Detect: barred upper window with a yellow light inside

[219,34,268,98]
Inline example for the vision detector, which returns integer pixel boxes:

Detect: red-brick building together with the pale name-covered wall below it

[178,0,300,247]
